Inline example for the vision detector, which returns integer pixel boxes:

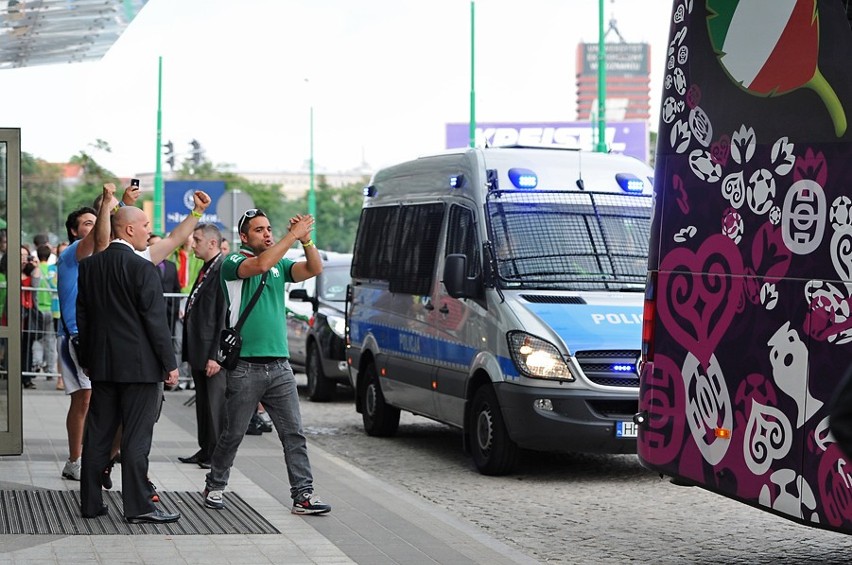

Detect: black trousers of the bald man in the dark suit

[80,381,161,517]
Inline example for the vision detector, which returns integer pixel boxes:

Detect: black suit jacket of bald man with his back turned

[77,242,177,383]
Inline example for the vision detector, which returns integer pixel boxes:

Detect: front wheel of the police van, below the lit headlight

[468,386,518,475]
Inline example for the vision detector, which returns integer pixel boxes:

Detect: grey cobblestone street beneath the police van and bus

[292,382,852,564]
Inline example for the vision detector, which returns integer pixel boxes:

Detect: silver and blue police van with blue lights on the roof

[346,147,653,475]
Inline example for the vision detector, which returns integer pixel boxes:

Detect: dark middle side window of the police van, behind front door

[389,203,444,294]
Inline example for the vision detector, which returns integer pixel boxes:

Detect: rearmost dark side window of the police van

[352,206,400,281]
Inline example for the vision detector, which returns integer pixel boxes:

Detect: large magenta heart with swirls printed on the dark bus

[657,234,743,367]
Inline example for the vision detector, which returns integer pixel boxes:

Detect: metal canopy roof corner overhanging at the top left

[0,0,147,69]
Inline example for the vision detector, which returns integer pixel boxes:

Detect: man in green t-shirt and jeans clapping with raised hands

[204,208,331,514]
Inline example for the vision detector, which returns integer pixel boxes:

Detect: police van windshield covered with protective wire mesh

[486,190,651,292]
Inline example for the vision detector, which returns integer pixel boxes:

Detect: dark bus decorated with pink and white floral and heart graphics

[635,0,852,533]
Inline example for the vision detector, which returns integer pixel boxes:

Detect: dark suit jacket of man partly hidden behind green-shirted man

[183,254,228,370]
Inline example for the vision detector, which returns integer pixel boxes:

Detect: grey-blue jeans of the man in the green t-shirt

[207,359,313,499]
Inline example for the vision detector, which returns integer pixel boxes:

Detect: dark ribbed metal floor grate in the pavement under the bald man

[0,490,281,535]
